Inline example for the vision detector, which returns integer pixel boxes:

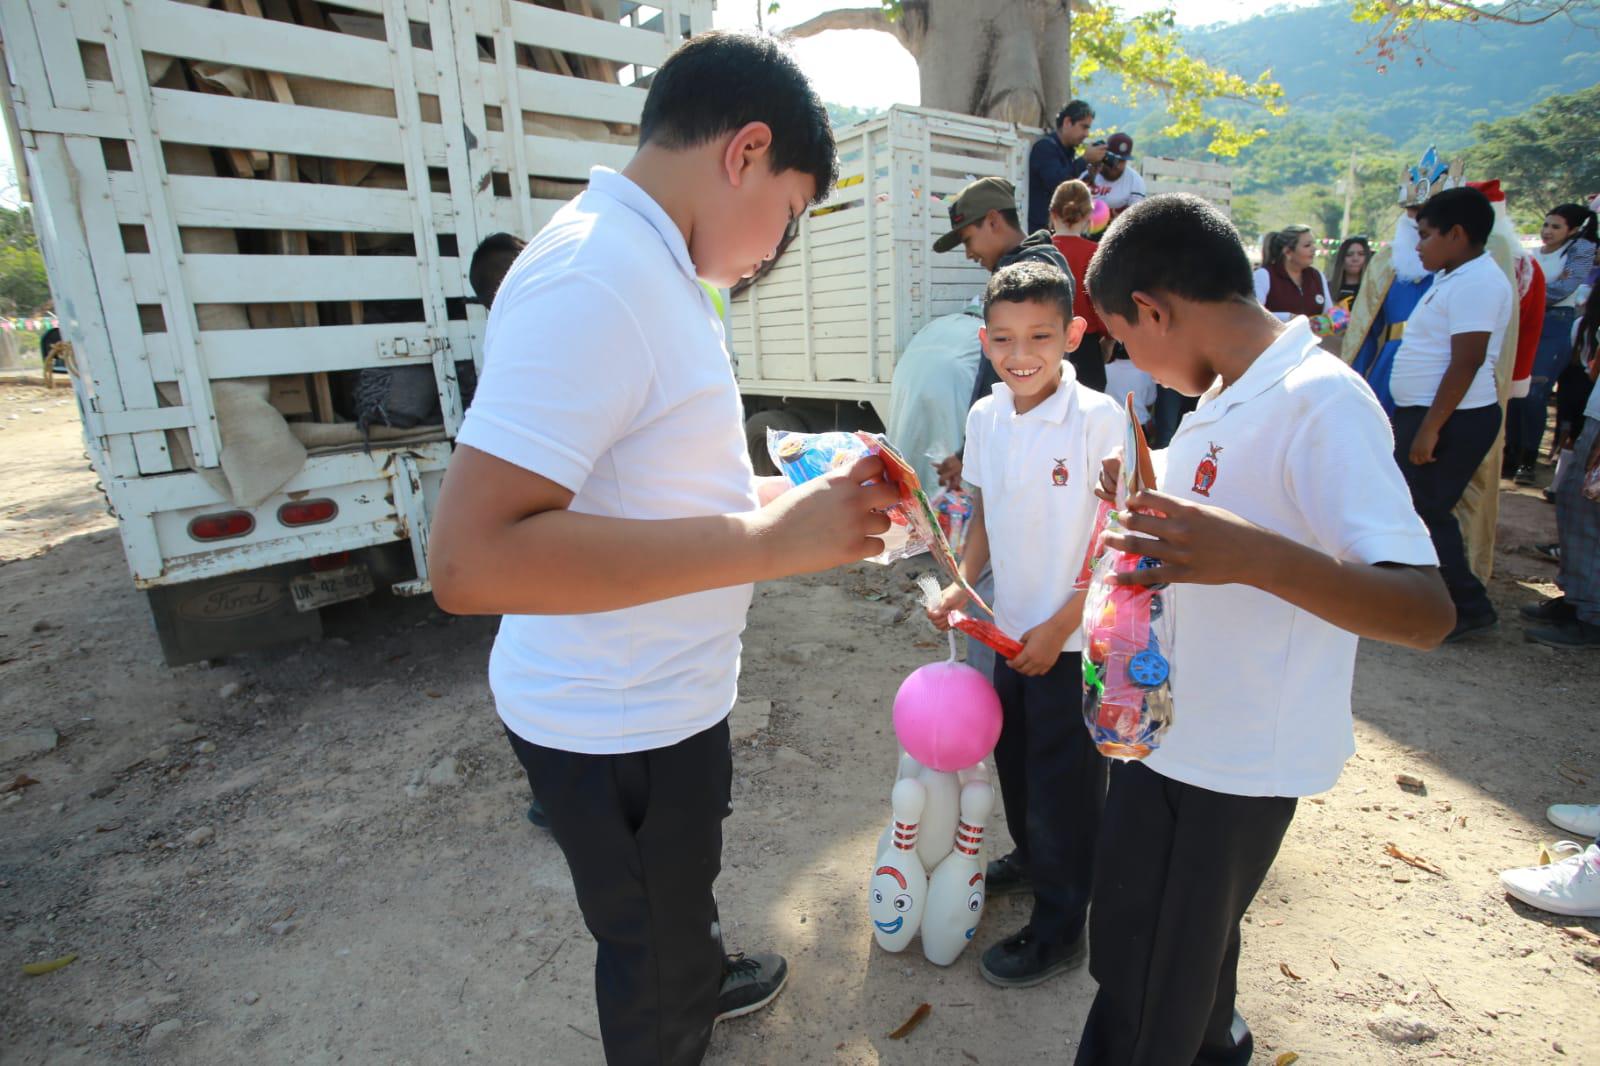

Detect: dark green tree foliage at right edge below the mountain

[1467,86,1600,229]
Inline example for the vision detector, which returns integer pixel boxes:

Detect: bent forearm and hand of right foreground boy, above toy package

[1106,491,1456,650]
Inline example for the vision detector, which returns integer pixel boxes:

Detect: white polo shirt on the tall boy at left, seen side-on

[458,166,757,754]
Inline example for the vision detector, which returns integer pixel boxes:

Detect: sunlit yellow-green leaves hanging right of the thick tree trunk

[1072,5,1288,157]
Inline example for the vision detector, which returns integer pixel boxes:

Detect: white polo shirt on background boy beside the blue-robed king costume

[1389,251,1512,411]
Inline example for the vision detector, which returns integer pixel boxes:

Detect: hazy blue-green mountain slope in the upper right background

[1100,0,1600,157]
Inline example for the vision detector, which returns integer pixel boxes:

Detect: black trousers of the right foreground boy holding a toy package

[1077,762,1296,1066]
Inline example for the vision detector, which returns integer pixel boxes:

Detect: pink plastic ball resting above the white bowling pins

[894,663,1000,771]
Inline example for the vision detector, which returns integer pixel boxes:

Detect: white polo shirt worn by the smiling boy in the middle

[962,360,1128,651]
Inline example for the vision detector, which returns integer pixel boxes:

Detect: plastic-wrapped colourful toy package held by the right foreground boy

[1078,395,1178,759]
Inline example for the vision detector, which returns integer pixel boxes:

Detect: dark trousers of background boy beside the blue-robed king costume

[1392,403,1501,618]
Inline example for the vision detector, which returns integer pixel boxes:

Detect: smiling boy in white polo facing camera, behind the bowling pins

[930,262,1126,988]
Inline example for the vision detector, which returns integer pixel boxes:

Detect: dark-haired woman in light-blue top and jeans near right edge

[1504,203,1600,485]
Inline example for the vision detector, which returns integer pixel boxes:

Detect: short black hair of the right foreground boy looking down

[1083,192,1256,322]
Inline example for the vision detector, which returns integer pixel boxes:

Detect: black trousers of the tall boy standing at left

[506,719,733,1066]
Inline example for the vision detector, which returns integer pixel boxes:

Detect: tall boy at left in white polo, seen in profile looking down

[429,34,896,1066]
